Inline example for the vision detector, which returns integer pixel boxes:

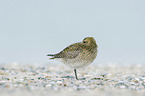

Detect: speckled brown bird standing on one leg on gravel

[47,37,98,80]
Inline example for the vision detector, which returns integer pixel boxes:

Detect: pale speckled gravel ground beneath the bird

[0,63,145,96]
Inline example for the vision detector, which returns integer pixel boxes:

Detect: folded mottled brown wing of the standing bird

[53,43,83,59]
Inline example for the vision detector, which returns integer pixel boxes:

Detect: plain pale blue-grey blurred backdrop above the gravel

[0,0,145,64]
